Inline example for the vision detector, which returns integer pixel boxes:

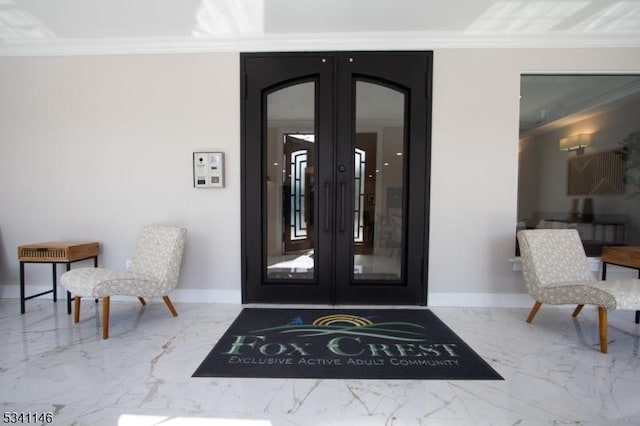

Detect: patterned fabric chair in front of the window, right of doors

[517,229,640,353]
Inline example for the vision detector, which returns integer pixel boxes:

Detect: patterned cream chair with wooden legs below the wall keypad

[60,225,187,339]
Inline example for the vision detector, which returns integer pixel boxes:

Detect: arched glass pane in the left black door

[265,81,316,280]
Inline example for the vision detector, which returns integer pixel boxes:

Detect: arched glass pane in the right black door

[353,81,406,282]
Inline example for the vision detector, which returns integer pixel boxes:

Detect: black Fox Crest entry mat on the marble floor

[193,308,503,380]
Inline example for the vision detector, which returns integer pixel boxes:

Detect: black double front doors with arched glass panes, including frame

[241,52,432,305]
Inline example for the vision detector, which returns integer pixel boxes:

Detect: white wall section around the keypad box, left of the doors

[0,54,240,300]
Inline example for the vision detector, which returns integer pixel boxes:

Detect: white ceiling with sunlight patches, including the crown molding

[0,0,640,56]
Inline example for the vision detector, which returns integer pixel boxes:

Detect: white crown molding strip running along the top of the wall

[0,32,640,57]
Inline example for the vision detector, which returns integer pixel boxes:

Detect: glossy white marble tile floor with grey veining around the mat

[0,299,640,426]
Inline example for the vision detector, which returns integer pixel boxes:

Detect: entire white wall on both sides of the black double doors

[0,46,640,306]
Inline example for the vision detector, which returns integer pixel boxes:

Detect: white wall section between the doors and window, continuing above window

[429,49,640,305]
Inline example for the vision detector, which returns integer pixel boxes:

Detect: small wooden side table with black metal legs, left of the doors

[18,241,100,314]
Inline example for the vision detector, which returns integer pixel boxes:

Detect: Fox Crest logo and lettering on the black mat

[220,312,459,367]
